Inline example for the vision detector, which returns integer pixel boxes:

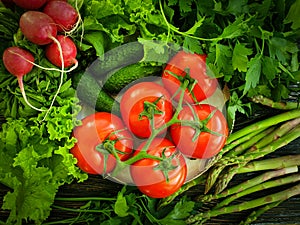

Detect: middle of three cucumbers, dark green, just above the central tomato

[103,63,162,94]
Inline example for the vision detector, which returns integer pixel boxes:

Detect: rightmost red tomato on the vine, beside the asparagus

[170,104,228,159]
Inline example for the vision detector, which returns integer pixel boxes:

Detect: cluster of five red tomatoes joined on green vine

[71,51,228,198]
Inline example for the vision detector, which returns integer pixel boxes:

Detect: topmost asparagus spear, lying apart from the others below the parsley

[251,95,300,110]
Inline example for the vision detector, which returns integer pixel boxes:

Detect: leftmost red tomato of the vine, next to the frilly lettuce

[71,112,133,174]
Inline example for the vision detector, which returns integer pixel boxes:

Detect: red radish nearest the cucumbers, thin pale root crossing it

[45,35,77,67]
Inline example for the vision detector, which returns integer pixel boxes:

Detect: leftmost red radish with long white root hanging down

[3,47,45,111]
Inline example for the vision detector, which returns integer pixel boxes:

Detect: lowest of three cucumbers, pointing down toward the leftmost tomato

[72,72,120,115]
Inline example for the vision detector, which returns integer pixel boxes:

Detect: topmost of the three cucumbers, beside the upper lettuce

[87,42,144,79]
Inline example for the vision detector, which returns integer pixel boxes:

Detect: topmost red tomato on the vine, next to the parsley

[162,51,218,103]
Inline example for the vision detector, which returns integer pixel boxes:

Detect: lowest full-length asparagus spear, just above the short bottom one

[185,184,300,224]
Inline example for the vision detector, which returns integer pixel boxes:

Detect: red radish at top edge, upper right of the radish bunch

[43,0,79,32]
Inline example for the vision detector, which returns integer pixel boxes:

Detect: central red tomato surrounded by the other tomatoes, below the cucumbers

[120,82,173,138]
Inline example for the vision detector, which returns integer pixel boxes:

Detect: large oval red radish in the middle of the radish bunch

[20,11,57,45]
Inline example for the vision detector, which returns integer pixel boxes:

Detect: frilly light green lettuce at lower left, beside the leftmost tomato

[0,98,87,224]
